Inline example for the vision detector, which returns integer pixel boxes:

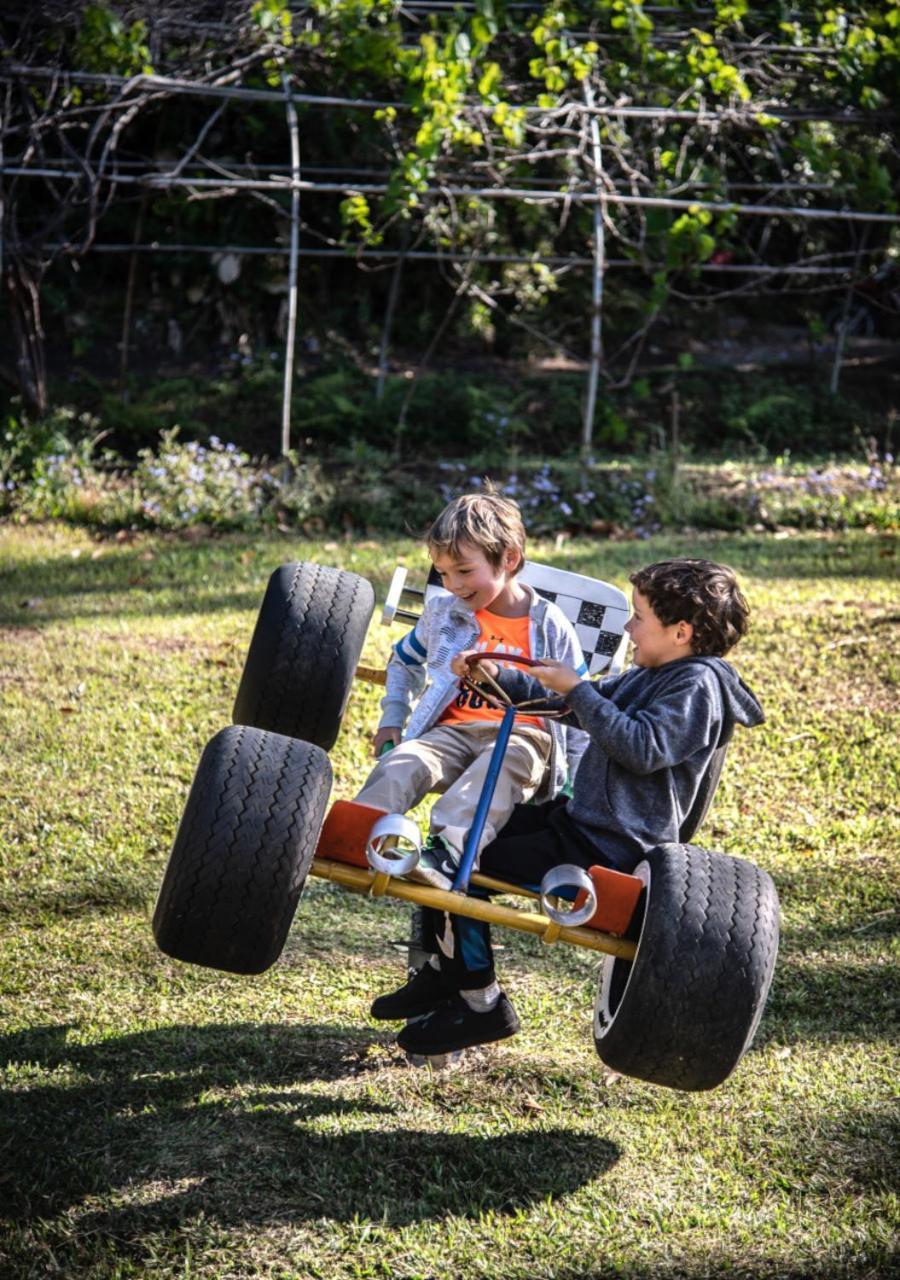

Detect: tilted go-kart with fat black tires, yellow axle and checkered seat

[154,562,778,1091]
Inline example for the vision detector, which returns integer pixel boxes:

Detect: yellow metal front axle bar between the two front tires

[310,858,636,960]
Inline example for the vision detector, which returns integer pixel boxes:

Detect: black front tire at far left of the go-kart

[154,726,332,973]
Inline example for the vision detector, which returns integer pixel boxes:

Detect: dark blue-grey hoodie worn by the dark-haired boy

[499,657,764,870]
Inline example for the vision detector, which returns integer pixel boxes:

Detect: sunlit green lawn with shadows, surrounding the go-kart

[0,526,900,1280]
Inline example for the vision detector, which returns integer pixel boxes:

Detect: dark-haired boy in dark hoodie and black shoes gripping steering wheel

[379,559,763,1055]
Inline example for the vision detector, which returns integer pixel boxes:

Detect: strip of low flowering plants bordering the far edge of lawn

[0,410,900,538]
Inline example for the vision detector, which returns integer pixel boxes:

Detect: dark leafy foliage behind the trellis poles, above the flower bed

[0,0,900,471]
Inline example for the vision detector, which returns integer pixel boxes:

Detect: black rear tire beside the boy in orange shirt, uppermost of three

[232,562,375,751]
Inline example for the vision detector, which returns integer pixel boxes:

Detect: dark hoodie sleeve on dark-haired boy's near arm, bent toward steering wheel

[566,667,722,774]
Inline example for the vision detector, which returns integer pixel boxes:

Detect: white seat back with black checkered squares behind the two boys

[382,561,629,676]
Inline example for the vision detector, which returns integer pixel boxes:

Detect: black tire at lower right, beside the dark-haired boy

[594,845,778,1091]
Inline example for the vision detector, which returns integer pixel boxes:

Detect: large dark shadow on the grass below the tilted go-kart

[0,1023,618,1240]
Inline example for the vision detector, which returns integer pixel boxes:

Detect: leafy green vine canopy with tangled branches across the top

[0,0,900,410]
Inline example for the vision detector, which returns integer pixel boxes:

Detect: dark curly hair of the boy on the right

[629,558,750,657]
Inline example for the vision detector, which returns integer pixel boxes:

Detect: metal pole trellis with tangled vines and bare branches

[0,0,900,454]
